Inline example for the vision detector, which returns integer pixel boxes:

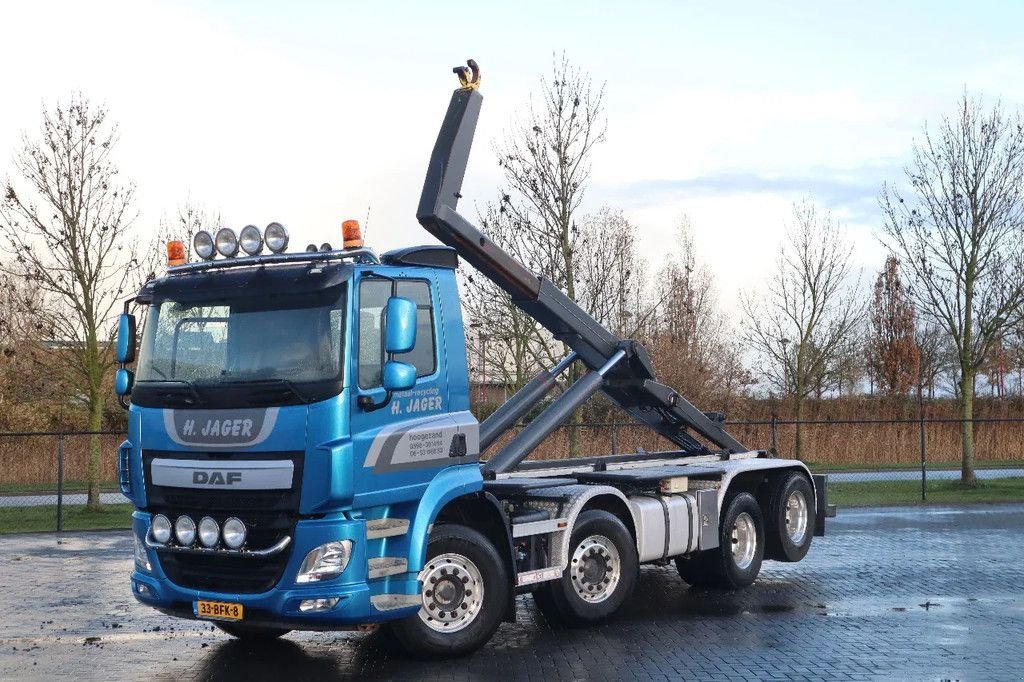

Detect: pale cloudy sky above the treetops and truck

[0,0,1024,315]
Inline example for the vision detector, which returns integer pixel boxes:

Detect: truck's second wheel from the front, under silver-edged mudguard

[534,509,639,626]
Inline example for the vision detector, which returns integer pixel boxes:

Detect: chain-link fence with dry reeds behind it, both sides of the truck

[0,411,1024,535]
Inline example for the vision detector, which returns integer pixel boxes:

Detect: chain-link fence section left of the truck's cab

[0,431,132,535]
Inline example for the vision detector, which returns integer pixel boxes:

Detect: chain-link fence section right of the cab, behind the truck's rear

[509,411,1024,507]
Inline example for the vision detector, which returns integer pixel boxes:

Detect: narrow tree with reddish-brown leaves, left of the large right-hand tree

[865,256,921,395]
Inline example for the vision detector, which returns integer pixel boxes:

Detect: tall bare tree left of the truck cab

[0,95,138,510]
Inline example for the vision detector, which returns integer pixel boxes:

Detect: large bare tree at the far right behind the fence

[880,94,1024,485]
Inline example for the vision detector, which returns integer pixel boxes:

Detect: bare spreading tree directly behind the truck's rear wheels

[740,201,863,458]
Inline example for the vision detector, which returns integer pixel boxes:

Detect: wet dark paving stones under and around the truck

[0,505,1024,682]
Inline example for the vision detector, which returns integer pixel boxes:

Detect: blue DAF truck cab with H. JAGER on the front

[121,240,482,628]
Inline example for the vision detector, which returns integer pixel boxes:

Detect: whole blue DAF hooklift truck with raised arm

[116,60,828,656]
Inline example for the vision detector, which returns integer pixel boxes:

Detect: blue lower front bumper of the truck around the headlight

[131,511,420,630]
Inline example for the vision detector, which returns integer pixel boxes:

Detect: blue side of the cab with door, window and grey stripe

[350,269,475,507]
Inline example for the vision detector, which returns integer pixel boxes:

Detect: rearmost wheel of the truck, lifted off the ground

[765,471,815,561]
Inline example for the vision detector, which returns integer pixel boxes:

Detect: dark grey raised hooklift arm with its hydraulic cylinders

[416,59,746,466]
